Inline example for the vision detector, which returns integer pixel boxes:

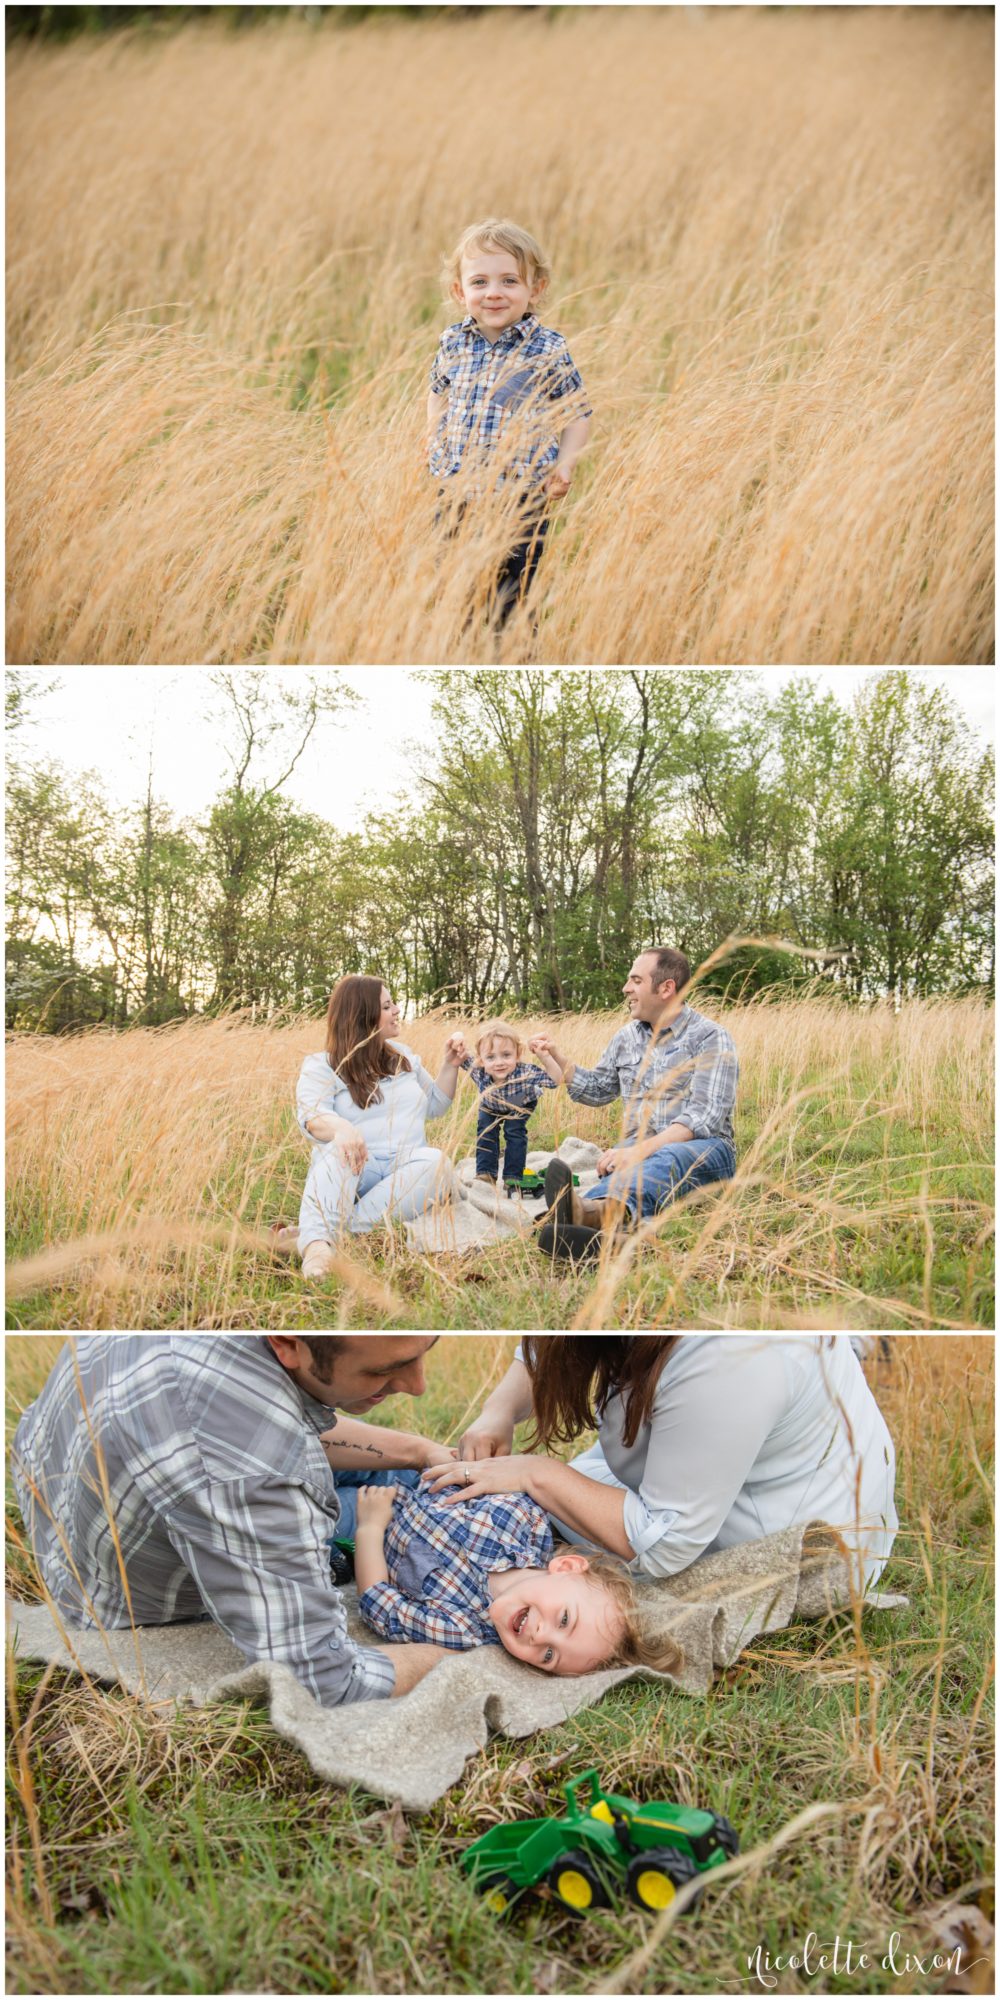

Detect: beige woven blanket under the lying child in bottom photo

[8,1522,906,1812]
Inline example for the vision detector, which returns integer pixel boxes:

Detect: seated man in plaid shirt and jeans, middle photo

[528,946,738,1262]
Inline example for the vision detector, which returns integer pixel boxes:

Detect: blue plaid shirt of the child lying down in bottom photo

[360,1486,554,1652]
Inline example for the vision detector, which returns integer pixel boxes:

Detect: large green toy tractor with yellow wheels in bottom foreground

[462,1770,740,1916]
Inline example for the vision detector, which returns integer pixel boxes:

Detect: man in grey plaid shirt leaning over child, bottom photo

[12,1334,452,1706]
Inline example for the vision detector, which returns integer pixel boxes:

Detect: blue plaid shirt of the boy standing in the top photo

[430,312,590,484]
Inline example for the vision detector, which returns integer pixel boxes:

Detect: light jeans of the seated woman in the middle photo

[298,1140,452,1256]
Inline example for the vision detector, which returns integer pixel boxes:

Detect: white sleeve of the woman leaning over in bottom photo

[624,1336,790,1576]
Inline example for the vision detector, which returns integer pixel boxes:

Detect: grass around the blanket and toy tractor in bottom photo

[8,1336,994,1994]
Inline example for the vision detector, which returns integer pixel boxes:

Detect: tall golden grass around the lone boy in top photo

[8,8,992,664]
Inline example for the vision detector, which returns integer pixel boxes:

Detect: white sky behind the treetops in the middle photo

[12,666,994,832]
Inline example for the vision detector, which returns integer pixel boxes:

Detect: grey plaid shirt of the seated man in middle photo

[566,1006,740,1144]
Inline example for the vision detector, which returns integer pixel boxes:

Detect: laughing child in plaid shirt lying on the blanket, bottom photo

[354,1486,680,1674]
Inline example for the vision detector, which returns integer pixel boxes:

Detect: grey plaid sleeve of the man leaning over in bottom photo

[152,1478,396,1708]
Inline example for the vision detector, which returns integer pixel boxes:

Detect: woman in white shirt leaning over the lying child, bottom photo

[424,1334,898,1584]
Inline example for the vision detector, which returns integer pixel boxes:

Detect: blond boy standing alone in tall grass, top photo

[428,218,590,624]
